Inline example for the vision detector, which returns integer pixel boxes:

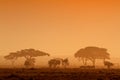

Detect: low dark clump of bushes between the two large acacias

[48,58,69,68]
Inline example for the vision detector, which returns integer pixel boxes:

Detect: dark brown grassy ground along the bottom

[0,68,120,80]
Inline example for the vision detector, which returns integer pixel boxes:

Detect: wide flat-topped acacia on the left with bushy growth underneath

[4,49,50,68]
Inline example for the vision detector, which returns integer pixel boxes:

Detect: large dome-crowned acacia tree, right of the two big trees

[74,47,110,66]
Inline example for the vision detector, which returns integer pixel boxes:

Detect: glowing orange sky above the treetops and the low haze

[0,0,120,60]
